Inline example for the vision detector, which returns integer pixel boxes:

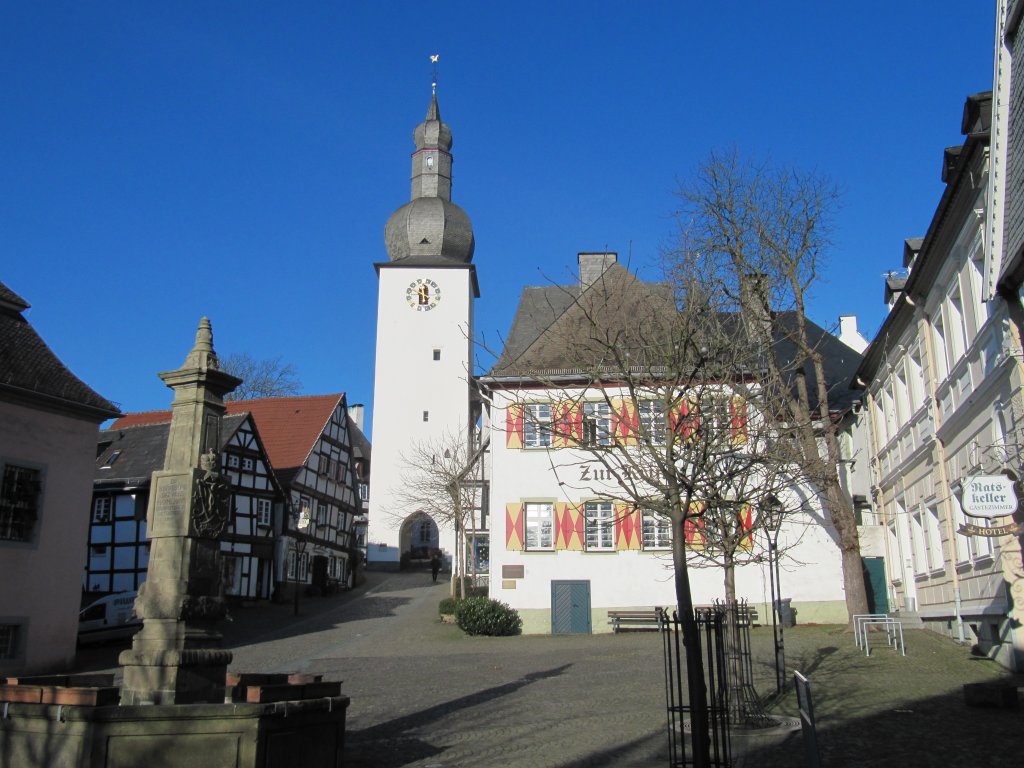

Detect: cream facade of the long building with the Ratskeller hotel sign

[857,88,1024,668]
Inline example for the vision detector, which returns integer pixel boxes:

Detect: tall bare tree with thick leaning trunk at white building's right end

[669,153,867,616]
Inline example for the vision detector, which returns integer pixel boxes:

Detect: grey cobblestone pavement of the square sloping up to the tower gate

[72,572,1024,768]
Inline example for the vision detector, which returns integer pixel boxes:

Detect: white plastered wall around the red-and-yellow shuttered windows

[489,390,846,633]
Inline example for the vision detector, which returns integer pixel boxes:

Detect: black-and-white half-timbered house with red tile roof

[100,394,370,597]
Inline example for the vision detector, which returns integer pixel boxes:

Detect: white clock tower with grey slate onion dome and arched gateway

[367,93,479,567]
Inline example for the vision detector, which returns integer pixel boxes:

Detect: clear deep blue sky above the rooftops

[0,0,994,434]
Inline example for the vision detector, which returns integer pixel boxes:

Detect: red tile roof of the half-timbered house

[109,393,345,472]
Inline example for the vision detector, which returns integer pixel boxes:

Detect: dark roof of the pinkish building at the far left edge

[0,283,120,424]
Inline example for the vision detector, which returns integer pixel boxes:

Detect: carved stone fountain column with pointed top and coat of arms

[119,317,242,705]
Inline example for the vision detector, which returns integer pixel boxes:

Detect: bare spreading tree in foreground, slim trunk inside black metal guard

[485,257,803,764]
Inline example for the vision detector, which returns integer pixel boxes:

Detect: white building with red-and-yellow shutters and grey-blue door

[480,253,859,634]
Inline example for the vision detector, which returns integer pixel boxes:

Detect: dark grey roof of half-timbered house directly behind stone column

[93,412,249,485]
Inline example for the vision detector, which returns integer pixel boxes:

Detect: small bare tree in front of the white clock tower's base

[389,432,485,595]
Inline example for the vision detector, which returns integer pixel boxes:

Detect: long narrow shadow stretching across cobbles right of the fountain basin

[345,664,572,768]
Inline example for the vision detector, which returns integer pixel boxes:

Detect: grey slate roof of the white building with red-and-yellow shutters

[484,263,861,412]
